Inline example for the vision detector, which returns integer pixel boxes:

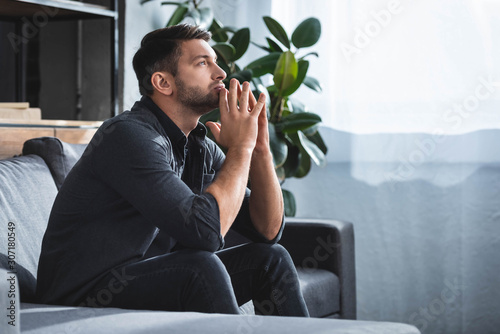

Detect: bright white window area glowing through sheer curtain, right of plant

[272,0,500,134]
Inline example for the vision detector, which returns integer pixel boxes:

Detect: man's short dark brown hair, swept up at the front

[132,24,212,95]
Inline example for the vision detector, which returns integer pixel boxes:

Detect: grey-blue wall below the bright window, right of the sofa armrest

[284,127,500,334]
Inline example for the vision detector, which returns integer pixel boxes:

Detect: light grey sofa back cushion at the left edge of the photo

[0,155,57,301]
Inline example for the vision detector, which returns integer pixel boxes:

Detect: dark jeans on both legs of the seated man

[81,243,309,317]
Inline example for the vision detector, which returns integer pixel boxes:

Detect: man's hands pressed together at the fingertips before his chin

[207,79,269,152]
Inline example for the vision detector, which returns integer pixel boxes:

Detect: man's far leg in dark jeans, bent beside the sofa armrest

[216,243,309,317]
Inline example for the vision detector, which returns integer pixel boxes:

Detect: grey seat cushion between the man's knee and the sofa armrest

[297,268,340,318]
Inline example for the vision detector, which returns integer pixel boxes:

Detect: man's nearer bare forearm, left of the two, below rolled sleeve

[206,149,252,237]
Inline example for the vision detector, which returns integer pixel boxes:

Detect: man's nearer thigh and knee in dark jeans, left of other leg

[80,249,239,314]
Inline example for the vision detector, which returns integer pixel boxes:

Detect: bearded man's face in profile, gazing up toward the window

[175,39,226,115]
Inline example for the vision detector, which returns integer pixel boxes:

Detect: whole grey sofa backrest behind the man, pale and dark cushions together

[0,137,87,302]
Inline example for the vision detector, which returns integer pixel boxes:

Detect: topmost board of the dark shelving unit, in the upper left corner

[0,0,118,21]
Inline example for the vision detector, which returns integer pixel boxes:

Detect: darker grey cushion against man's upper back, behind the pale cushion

[23,137,87,189]
